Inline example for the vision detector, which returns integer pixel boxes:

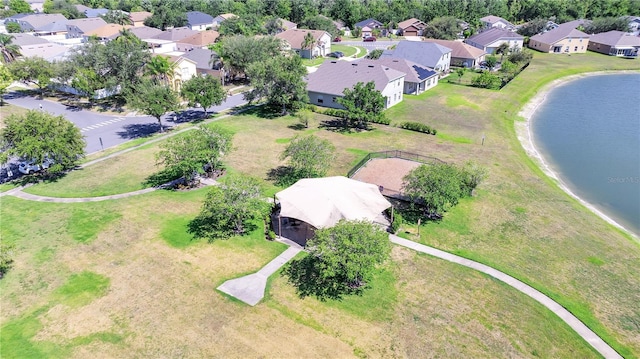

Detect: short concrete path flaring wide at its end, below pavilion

[218,246,302,306]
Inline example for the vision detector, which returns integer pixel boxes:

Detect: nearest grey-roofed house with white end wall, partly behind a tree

[306,61,405,109]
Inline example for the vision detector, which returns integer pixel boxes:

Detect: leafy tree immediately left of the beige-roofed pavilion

[188,176,270,242]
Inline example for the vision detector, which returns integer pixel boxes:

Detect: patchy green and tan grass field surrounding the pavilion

[0,54,640,358]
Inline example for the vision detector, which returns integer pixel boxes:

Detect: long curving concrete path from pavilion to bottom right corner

[389,235,622,359]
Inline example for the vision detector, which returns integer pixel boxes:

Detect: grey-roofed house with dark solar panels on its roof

[358,57,438,95]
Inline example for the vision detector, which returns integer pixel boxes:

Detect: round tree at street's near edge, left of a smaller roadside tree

[127,79,179,132]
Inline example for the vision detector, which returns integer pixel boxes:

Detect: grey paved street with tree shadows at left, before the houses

[4,92,246,154]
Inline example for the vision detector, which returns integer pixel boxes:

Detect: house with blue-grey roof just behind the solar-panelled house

[381,41,451,73]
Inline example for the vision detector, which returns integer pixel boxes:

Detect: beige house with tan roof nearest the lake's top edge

[529,20,590,54]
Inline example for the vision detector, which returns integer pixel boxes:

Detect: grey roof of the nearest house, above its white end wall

[306,61,405,96]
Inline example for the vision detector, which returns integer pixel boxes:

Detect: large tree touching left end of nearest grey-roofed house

[244,55,307,114]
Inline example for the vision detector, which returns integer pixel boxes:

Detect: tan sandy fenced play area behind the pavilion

[352,158,422,194]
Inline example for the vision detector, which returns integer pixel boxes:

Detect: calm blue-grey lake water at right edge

[531,74,640,235]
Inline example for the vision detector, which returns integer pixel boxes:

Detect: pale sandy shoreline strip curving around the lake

[514,71,640,241]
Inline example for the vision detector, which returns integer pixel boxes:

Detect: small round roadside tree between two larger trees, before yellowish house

[181,74,227,116]
